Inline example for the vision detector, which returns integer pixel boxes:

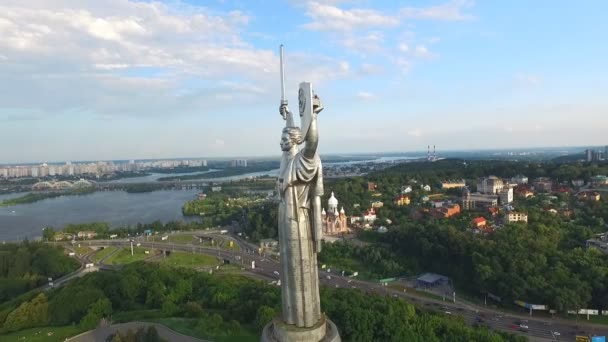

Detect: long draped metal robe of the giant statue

[278,151,323,327]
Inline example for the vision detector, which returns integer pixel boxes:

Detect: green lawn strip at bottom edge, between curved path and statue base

[150,317,260,342]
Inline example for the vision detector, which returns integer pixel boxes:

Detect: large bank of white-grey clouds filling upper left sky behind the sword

[0,0,352,118]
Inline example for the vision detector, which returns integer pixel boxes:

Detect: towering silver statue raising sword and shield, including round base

[262,47,340,342]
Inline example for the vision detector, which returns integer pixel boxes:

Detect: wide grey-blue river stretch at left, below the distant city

[0,190,197,242]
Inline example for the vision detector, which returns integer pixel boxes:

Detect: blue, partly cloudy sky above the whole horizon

[0,0,608,163]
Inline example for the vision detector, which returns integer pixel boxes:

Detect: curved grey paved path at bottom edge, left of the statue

[66,322,209,342]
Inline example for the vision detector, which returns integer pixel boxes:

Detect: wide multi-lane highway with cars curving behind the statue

[59,239,608,341]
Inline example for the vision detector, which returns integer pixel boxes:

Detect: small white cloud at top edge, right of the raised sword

[399,0,474,21]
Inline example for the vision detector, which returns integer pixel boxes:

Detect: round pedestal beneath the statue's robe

[261,316,342,342]
